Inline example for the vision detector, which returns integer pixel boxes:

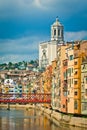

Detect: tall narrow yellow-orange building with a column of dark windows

[74,44,81,114]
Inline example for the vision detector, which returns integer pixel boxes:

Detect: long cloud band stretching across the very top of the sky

[0,0,87,19]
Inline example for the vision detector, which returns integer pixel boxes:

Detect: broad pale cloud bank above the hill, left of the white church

[0,36,46,63]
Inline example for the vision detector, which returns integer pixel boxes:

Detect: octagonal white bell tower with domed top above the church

[51,17,64,44]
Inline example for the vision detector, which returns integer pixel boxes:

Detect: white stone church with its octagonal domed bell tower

[39,18,64,68]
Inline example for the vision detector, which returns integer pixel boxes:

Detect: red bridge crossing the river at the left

[0,93,51,104]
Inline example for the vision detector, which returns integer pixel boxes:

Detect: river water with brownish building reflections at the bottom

[0,109,87,130]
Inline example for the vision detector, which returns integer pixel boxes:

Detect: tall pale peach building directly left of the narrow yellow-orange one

[66,43,74,113]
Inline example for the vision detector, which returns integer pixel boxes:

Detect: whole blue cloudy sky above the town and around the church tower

[0,0,87,63]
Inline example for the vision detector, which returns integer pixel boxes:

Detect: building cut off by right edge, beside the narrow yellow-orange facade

[80,41,87,115]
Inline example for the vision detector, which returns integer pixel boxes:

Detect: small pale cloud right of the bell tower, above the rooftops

[65,31,87,41]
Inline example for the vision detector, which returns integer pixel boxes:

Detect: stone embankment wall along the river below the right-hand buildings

[40,108,87,128]
